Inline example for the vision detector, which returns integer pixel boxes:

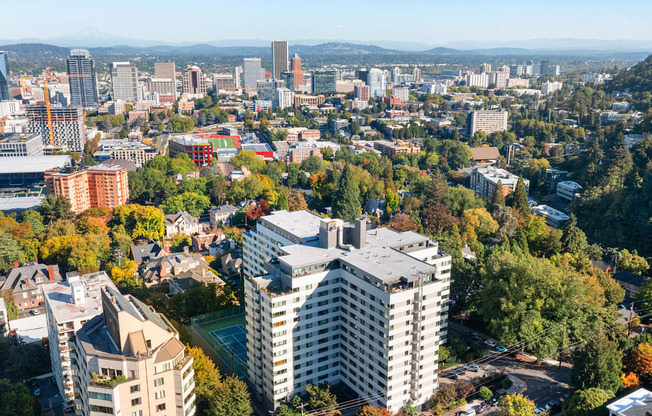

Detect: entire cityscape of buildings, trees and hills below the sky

[0,12,652,416]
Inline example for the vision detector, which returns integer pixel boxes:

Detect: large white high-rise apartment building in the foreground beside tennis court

[243,211,451,411]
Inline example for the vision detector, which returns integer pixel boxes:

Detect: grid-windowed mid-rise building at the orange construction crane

[26,105,86,154]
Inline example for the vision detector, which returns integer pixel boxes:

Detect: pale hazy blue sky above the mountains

[0,0,652,44]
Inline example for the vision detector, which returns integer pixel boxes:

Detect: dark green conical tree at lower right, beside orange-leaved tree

[570,332,623,393]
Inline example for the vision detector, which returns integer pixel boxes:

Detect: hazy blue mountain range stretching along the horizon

[0,41,652,59]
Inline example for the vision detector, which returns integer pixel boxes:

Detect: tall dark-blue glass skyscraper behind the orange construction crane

[68,49,98,108]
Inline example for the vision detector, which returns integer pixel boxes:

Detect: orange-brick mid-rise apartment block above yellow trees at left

[44,165,129,214]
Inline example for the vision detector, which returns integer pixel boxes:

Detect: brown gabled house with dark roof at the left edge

[0,261,61,310]
